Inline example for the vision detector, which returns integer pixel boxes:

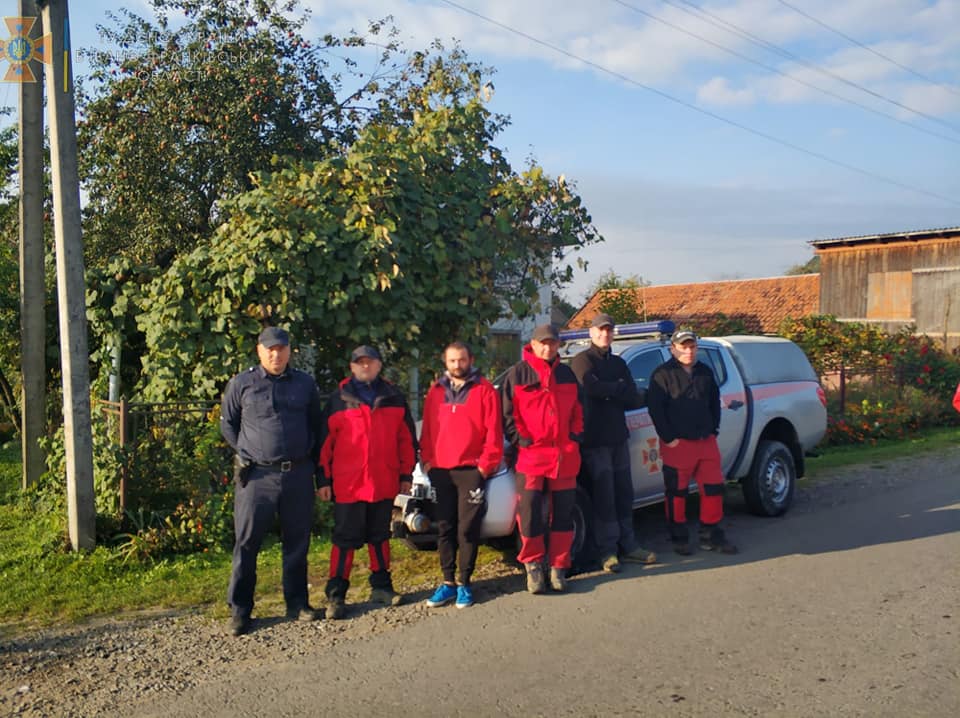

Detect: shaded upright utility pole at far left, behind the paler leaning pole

[19,0,50,489]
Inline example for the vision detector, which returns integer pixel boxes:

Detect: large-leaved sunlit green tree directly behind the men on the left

[127,50,599,398]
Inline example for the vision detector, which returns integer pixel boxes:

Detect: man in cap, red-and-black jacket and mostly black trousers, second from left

[319,346,417,618]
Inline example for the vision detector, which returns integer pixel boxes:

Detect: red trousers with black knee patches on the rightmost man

[660,436,723,526]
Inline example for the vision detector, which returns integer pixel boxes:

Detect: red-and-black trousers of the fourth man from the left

[516,472,577,568]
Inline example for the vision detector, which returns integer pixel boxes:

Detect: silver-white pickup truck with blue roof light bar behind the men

[393,321,827,564]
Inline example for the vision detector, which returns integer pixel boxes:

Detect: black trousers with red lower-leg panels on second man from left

[325,499,393,599]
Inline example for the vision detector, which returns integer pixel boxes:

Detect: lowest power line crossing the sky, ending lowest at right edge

[440,0,960,207]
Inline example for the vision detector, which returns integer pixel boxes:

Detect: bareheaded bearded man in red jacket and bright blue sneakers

[420,342,503,608]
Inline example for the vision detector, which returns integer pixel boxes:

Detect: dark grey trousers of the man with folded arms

[580,441,637,559]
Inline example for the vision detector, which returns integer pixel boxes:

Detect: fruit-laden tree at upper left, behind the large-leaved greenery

[78,0,390,266]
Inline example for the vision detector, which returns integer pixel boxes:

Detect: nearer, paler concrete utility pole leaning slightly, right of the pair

[41,0,96,551]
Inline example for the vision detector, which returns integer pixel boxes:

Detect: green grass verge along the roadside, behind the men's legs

[0,427,960,633]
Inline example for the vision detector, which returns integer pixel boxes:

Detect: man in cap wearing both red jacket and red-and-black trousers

[500,324,583,593]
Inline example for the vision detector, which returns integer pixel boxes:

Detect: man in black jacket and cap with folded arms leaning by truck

[570,314,657,573]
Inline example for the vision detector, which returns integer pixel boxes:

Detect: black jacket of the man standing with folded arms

[570,343,640,448]
